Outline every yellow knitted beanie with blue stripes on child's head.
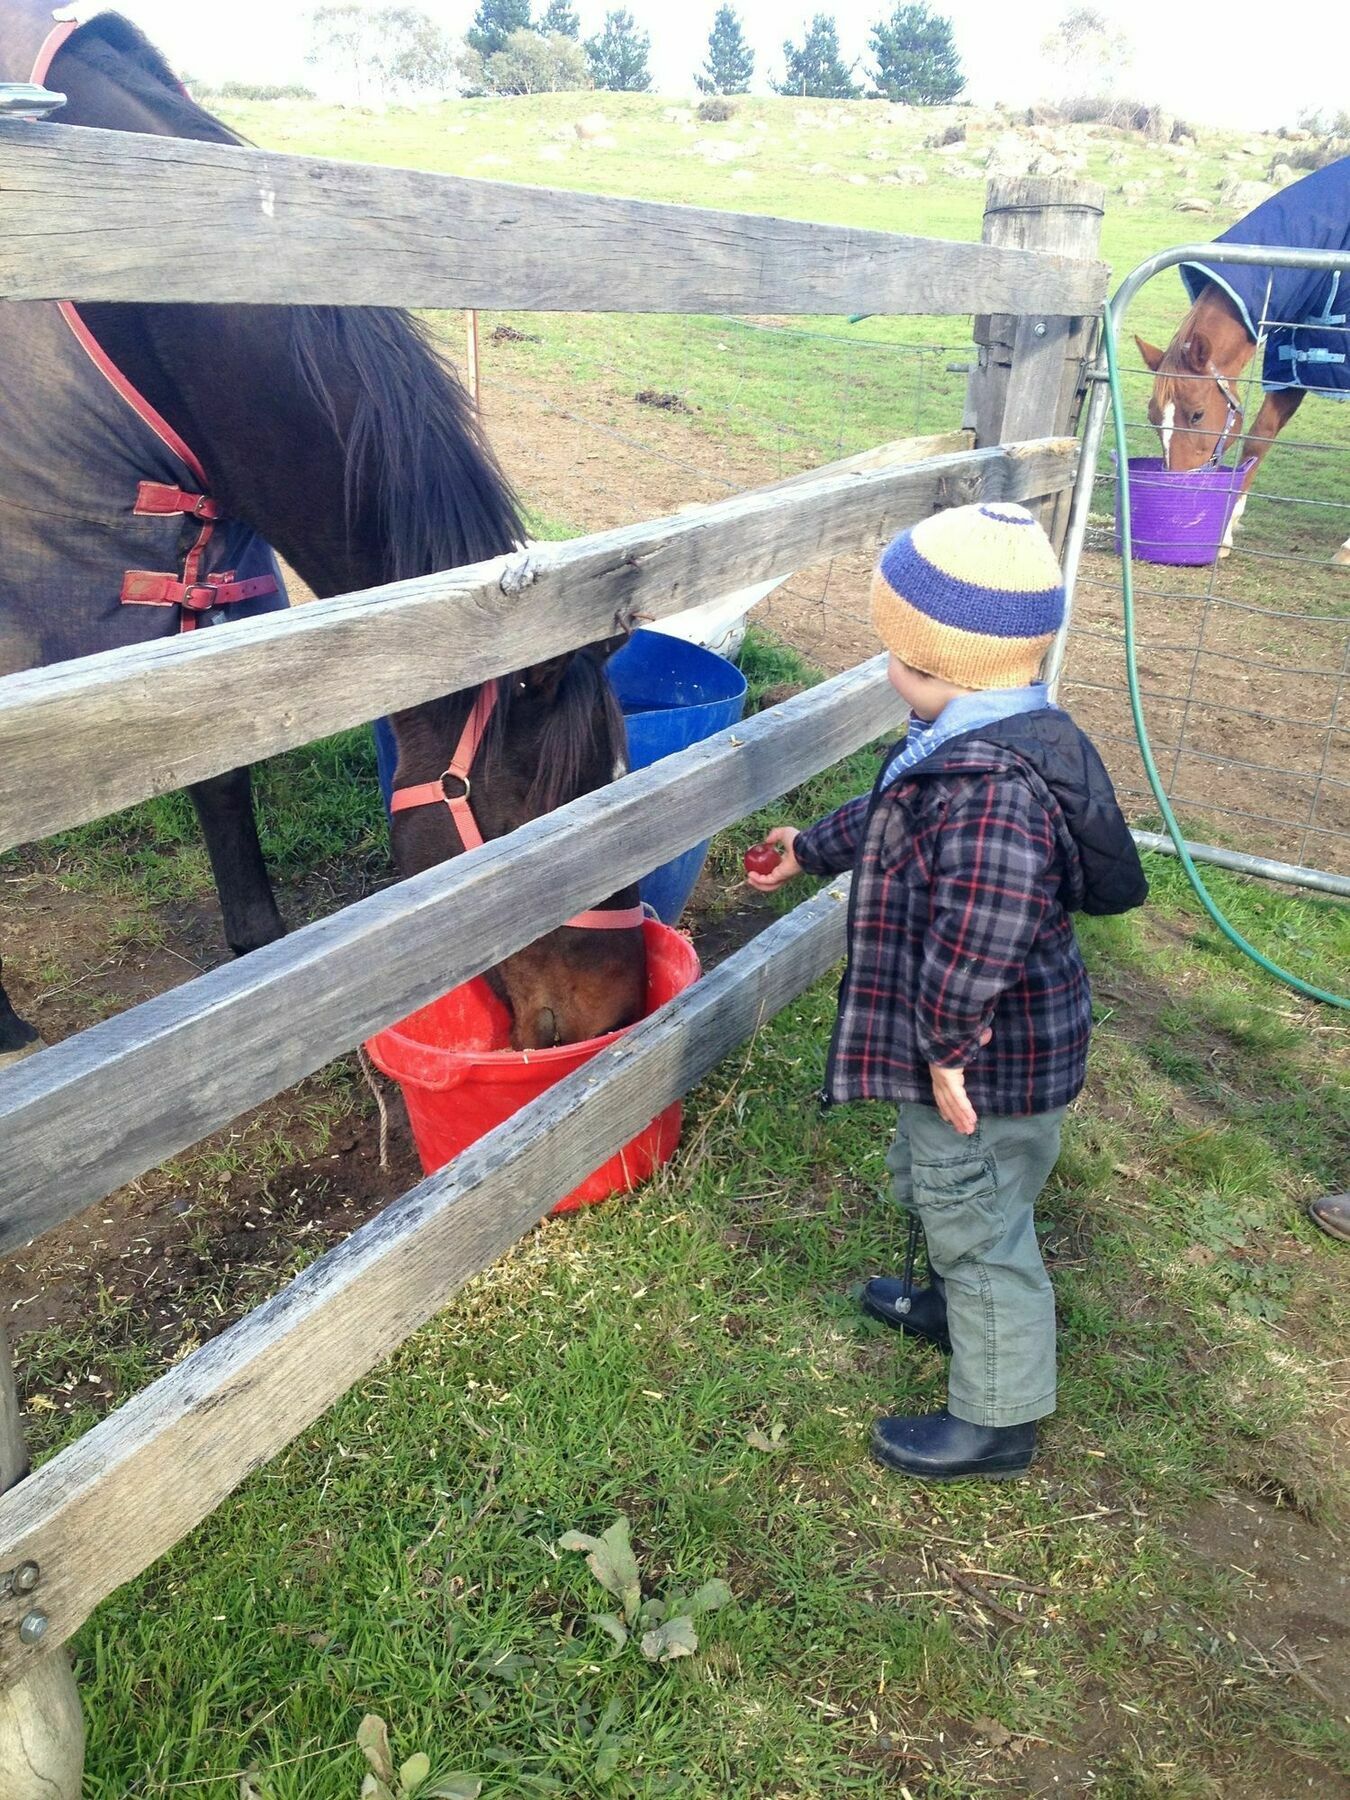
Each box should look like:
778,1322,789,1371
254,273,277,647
871,500,1064,688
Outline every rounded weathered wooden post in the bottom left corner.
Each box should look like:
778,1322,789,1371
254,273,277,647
0,1327,85,1800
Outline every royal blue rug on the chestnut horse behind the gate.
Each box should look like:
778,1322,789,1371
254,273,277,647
1181,157,1350,400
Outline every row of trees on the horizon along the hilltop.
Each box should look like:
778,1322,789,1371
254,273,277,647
308,0,965,106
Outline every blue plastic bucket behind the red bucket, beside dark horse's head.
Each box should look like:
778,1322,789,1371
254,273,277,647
605,632,745,925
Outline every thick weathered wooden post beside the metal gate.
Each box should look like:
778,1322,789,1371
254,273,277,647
965,175,1105,547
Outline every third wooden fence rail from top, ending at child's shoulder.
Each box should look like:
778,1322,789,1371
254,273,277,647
0,655,900,1255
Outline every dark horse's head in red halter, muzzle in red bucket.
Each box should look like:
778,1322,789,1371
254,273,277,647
392,639,646,1049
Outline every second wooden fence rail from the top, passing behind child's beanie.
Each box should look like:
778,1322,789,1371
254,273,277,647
0,439,1078,850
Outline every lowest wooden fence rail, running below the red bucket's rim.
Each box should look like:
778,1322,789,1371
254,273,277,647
0,884,846,1683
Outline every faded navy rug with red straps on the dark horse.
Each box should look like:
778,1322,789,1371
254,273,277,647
0,0,286,675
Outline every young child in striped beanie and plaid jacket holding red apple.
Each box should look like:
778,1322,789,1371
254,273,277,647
751,502,1148,1480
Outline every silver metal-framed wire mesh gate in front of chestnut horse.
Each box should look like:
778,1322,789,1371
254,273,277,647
1048,241,1350,896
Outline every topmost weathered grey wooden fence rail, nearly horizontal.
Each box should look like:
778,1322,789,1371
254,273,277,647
0,122,1107,315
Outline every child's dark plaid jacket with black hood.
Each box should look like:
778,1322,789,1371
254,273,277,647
796,707,1148,1114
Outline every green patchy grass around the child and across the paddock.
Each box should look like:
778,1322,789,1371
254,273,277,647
0,95,1350,1800
